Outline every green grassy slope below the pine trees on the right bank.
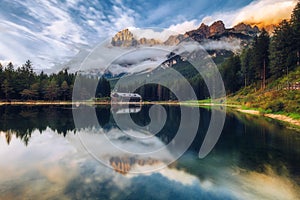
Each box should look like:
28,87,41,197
227,67,300,119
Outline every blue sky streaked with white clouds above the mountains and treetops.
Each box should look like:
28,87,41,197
0,0,296,69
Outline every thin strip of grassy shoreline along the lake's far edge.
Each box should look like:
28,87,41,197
0,100,300,127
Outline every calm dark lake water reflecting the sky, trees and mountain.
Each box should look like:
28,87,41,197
0,106,300,200
